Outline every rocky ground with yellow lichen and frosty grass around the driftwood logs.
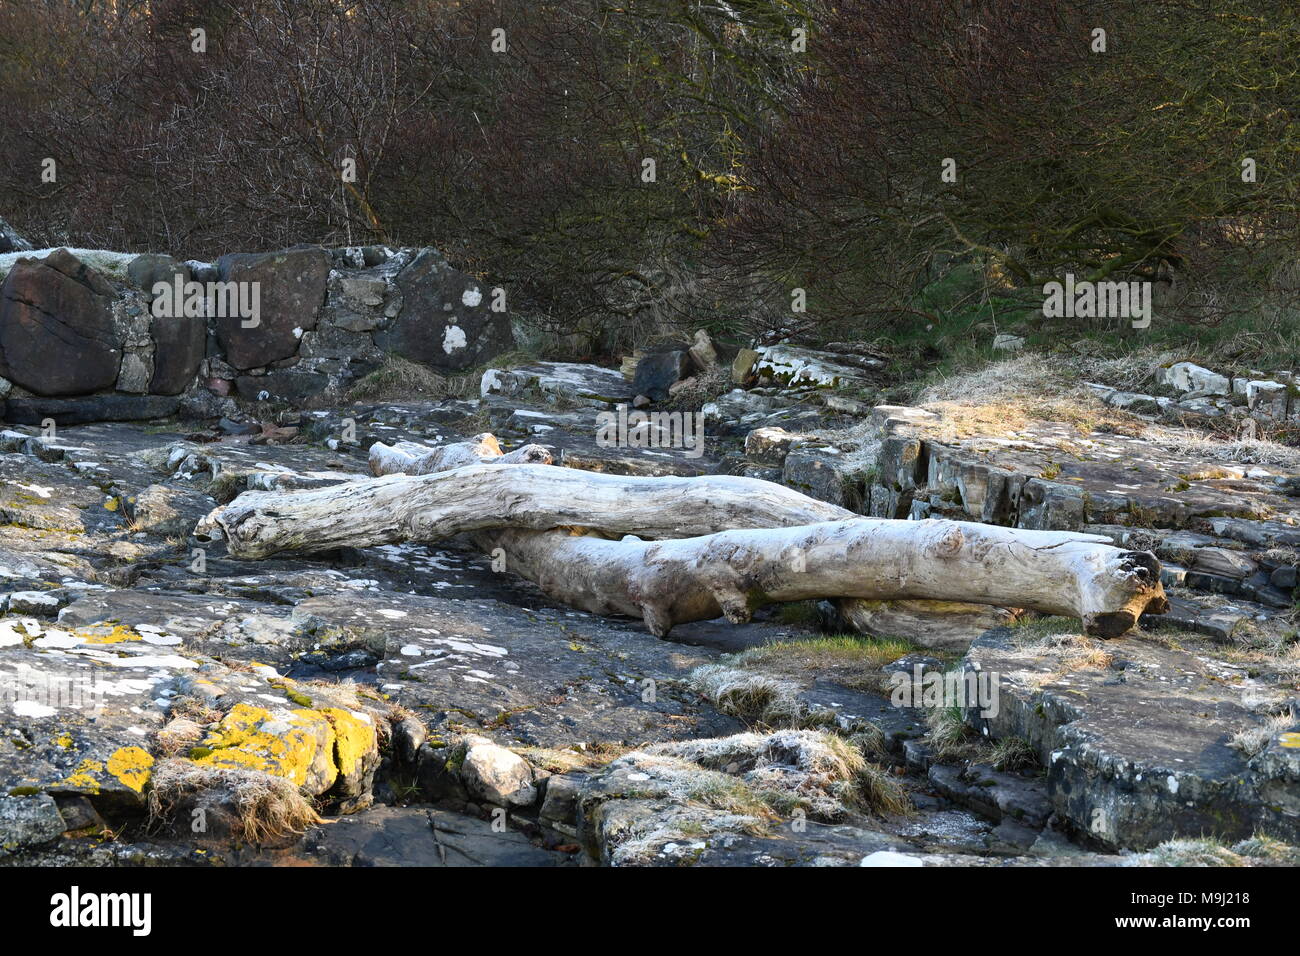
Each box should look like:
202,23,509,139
0,343,1300,866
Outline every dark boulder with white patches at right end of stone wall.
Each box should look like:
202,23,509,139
374,248,515,372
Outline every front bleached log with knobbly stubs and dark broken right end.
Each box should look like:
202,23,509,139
475,518,1169,637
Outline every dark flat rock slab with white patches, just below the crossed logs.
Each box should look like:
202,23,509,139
280,592,738,748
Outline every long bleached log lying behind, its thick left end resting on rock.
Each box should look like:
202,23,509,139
195,464,852,558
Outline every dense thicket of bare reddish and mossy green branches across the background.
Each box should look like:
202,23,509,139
0,0,1300,350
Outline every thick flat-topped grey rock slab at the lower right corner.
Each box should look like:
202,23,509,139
966,628,1300,849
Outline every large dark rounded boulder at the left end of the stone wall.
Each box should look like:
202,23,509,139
0,248,122,395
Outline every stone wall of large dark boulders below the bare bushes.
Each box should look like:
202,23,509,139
0,246,514,424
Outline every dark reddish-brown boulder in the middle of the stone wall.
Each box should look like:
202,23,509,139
215,248,330,369
